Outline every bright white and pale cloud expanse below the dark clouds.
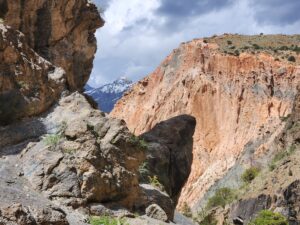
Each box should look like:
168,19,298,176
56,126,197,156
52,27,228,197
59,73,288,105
89,0,300,86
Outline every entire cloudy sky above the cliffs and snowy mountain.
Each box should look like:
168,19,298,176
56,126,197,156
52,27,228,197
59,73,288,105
89,0,300,87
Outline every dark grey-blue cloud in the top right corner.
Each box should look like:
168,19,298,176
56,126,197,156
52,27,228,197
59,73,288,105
250,0,300,25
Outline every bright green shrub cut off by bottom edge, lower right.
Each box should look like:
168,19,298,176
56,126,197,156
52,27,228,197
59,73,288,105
249,210,289,225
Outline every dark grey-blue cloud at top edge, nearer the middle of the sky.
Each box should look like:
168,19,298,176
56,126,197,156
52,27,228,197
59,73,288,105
157,0,233,19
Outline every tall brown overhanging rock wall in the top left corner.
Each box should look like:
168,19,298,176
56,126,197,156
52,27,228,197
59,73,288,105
0,0,104,91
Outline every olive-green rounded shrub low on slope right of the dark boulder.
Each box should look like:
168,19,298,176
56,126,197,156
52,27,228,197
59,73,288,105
206,187,236,210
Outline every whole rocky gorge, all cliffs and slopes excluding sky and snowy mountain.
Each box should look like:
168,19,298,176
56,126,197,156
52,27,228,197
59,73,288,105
0,0,300,225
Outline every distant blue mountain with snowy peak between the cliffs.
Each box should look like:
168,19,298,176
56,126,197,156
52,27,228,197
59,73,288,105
85,77,133,113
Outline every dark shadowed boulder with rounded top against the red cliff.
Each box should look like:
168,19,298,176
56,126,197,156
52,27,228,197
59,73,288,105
141,115,196,205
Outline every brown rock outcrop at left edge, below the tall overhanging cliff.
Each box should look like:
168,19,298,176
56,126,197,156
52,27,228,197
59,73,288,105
0,24,65,125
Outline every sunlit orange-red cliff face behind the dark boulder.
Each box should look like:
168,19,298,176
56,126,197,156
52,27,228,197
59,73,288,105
111,37,300,206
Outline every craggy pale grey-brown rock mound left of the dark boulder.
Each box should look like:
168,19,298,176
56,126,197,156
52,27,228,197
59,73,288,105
21,93,144,208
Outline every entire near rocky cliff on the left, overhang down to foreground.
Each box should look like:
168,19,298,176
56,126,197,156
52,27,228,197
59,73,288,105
0,0,195,225
